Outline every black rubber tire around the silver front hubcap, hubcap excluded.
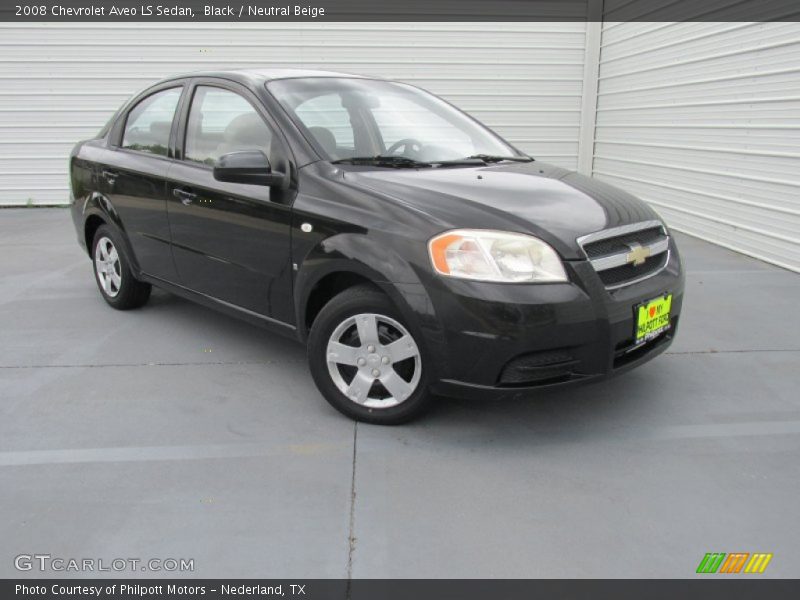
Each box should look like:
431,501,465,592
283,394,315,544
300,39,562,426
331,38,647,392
308,287,430,425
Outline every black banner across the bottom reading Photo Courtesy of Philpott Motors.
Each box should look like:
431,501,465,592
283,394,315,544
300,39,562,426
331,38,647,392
0,576,800,600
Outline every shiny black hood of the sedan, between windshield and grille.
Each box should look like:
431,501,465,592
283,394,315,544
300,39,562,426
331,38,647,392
344,161,659,258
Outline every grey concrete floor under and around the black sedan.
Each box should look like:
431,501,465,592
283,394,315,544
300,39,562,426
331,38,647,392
0,209,800,578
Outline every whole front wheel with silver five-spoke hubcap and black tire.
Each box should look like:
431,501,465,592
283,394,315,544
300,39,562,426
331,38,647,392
308,286,431,425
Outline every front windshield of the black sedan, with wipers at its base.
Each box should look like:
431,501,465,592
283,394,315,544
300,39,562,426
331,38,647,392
267,77,530,167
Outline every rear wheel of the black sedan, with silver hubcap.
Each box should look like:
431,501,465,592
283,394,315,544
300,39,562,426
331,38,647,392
92,225,152,310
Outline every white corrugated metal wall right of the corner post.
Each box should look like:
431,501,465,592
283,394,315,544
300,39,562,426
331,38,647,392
593,23,800,271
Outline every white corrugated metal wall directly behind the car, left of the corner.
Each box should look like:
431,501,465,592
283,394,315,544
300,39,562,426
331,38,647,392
0,23,585,205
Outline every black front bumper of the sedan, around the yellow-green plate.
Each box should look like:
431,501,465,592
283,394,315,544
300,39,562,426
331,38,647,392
426,238,684,398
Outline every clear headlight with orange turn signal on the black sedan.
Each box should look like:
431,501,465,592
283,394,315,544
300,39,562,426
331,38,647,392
428,229,567,283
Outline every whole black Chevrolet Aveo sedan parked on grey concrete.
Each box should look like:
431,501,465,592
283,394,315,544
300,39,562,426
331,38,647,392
71,70,684,424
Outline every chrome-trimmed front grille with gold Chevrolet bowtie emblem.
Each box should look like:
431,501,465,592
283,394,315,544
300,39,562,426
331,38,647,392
578,221,669,289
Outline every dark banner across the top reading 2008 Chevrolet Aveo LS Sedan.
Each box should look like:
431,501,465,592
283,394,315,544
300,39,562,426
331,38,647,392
0,0,800,23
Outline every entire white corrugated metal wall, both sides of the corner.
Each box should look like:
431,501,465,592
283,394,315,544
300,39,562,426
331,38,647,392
0,19,800,271
